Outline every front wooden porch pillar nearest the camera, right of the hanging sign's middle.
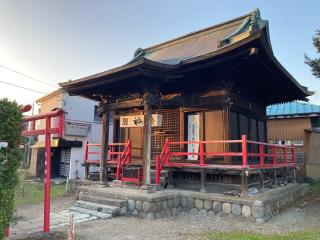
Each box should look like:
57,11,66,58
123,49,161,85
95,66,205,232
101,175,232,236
142,92,152,185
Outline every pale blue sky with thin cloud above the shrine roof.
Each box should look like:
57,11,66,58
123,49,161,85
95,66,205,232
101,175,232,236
0,0,320,104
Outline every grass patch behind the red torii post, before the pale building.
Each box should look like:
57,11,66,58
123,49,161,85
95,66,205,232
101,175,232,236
15,181,65,206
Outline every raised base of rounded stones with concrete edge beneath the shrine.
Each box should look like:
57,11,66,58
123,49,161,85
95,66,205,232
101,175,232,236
75,184,308,223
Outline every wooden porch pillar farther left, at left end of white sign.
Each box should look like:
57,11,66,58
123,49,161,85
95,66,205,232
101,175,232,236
100,102,110,185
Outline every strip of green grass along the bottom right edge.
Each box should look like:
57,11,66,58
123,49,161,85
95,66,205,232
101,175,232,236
201,229,320,240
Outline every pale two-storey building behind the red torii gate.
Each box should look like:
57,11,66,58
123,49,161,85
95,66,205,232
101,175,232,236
30,89,107,179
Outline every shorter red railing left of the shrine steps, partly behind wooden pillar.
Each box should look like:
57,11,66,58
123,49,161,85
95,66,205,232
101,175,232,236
84,139,131,180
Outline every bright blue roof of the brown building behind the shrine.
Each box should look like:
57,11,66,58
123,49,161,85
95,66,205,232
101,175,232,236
267,102,320,116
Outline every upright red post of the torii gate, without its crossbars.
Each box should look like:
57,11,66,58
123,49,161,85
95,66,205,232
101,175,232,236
43,117,51,232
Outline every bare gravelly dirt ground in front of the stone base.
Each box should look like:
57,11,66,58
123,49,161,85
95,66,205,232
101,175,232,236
11,188,320,240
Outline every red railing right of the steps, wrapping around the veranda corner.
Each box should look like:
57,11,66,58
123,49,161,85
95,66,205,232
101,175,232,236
155,135,295,184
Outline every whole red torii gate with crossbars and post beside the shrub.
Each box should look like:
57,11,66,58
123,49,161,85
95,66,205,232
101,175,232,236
22,109,64,232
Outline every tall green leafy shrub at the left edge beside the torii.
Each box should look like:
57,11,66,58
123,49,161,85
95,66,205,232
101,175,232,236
0,99,22,239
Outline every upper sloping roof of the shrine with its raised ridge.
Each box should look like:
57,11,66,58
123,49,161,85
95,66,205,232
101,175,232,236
131,9,267,65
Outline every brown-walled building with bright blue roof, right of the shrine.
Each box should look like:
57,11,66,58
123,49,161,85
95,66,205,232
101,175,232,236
267,102,320,179
